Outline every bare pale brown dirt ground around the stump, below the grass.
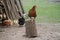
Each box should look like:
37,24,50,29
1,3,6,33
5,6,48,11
0,23,60,40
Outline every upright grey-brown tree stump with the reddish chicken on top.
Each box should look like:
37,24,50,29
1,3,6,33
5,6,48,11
25,19,37,37
